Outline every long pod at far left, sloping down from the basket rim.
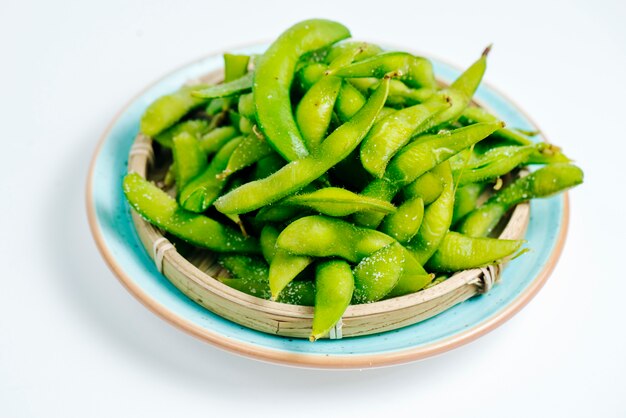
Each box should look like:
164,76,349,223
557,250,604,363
123,173,259,253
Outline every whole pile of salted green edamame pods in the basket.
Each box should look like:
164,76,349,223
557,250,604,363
123,19,583,341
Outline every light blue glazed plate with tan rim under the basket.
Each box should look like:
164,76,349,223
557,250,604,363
86,45,568,368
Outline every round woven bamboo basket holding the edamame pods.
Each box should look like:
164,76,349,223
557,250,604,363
128,71,530,339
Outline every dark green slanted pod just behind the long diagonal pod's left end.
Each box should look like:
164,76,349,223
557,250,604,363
178,137,243,213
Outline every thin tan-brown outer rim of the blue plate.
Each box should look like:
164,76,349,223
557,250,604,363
85,44,569,369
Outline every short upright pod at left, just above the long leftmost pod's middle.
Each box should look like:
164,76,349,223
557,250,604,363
172,132,207,193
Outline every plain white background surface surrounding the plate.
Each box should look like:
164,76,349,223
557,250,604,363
0,0,626,418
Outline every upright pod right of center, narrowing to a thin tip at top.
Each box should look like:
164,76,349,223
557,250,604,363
407,162,454,265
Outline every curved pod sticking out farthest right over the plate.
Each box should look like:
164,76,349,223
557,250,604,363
459,163,583,237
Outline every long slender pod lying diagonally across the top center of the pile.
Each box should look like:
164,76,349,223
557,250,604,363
215,80,389,213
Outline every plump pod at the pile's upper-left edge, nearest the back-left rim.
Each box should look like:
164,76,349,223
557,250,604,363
139,86,207,137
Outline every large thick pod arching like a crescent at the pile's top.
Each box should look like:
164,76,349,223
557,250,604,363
253,19,350,161
